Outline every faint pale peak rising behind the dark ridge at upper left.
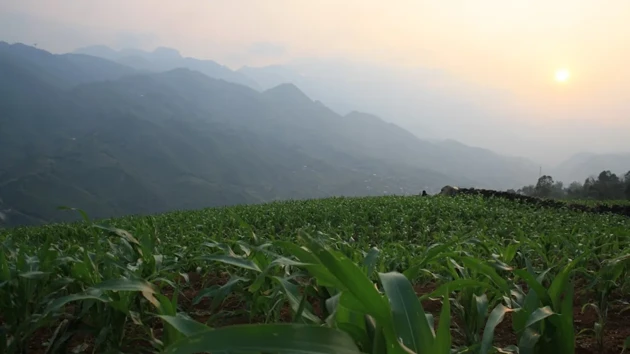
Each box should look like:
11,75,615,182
75,46,260,89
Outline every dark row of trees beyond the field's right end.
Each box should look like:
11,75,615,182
509,171,630,200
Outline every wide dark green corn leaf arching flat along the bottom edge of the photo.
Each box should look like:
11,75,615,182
164,324,361,354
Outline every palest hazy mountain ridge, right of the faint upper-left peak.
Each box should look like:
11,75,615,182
238,59,528,142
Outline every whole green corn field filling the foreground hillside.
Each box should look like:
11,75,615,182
0,195,630,354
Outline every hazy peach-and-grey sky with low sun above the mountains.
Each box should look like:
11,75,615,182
0,0,630,162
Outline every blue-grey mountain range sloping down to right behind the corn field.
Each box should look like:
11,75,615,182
0,42,628,225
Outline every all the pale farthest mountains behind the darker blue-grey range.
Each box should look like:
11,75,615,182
69,46,630,186
